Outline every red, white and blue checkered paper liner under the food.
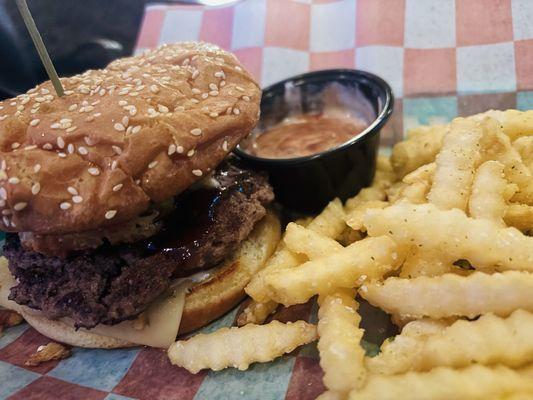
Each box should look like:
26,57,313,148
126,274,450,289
0,0,533,400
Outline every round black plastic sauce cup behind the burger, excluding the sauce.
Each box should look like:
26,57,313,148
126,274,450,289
235,69,394,214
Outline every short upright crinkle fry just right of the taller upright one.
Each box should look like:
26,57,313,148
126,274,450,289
468,161,516,227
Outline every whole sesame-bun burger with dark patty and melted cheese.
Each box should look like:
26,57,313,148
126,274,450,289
0,43,280,348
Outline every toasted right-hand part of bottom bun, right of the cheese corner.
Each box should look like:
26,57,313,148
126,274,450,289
179,211,281,334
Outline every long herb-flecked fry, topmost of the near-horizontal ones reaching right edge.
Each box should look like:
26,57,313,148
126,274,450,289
364,203,533,271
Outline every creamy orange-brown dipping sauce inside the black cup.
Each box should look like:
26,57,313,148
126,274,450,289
246,114,368,158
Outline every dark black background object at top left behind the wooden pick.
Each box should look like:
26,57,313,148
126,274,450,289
0,0,146,99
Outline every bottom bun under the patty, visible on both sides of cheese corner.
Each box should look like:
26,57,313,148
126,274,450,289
0,211,281,349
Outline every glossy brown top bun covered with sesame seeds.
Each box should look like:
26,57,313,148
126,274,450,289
0,43,261,234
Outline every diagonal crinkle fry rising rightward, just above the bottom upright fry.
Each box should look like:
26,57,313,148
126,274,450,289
265,236,403,306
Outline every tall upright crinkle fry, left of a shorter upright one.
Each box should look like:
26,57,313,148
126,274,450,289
428,118,483,210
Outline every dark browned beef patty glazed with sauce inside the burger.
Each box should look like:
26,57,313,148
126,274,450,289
4,163,274,328
